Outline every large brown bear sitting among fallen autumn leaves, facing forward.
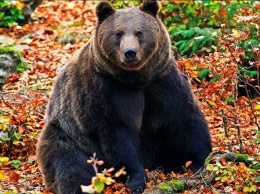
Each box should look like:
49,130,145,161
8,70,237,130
37,0,211,194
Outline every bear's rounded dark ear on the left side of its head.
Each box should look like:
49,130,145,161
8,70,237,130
96,1,116,24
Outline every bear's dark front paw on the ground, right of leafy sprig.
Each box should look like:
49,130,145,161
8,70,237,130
126,174,148,194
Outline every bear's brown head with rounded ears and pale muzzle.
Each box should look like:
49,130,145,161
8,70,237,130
95,0,170,72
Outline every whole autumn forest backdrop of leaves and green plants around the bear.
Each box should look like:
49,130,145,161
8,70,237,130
0,0,260,194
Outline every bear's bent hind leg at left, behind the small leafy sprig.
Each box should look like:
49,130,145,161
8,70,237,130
37,125,95,194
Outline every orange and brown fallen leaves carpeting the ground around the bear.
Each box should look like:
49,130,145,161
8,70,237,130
0,1,260,194
